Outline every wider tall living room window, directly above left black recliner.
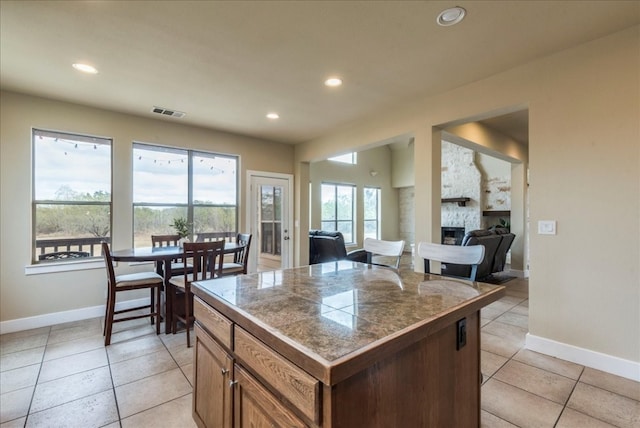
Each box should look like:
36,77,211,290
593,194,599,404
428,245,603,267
321,183,355,243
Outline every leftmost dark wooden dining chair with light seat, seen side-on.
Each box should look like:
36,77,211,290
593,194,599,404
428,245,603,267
102,242,164,346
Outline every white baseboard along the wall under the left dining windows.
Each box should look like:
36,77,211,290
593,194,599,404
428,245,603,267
0,297,149,334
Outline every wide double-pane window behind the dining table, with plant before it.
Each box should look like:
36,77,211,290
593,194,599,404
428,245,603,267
133,143,238,247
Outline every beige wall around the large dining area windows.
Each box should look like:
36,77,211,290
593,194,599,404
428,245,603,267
0,92,294,321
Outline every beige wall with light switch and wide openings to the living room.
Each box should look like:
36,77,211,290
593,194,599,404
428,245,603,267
296,26,640,368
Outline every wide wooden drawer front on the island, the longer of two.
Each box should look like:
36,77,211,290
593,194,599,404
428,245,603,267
234,327,320,423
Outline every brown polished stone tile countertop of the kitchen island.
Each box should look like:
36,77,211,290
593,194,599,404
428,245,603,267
192,261,505,385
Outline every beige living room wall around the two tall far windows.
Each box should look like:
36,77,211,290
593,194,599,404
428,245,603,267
310,145,400,249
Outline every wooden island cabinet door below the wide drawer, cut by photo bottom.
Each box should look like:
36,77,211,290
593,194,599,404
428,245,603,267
234,365,307,428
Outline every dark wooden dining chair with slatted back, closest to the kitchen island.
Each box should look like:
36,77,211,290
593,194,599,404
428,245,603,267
169,241,224,347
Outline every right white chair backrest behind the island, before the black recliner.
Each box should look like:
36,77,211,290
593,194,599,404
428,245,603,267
418,242,485,281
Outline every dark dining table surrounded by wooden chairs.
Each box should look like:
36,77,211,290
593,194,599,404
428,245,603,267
111,241,245,334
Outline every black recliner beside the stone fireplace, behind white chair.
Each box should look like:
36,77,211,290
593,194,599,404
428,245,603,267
441,227,515,282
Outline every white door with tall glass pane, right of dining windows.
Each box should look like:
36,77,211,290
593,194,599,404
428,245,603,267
247,171,293,272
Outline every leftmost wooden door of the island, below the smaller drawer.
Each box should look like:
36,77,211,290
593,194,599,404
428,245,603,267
193,323,233,428
